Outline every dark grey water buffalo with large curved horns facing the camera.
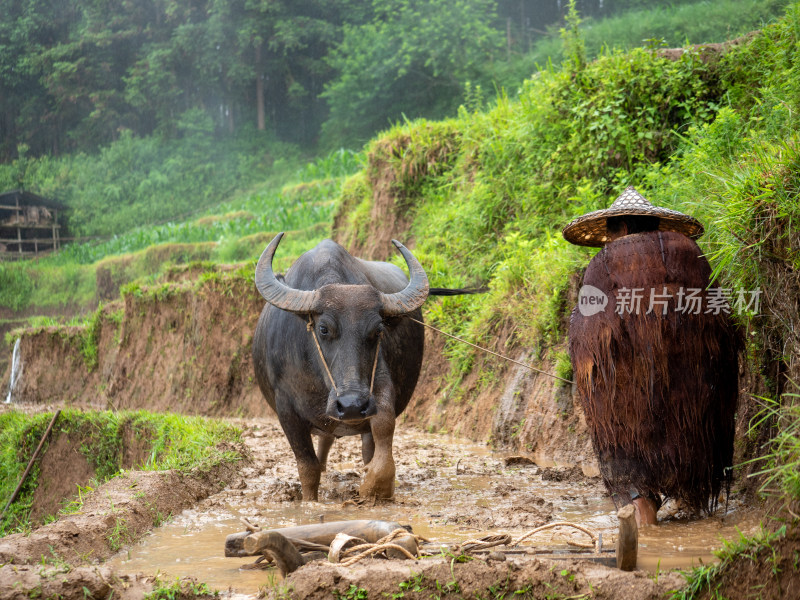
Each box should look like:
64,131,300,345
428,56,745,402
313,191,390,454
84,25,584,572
253,233,429,500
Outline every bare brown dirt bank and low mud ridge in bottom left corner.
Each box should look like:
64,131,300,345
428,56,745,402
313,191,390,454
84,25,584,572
0,405,244,600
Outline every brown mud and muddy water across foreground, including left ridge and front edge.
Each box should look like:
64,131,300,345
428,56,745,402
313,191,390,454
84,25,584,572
0,404,757,599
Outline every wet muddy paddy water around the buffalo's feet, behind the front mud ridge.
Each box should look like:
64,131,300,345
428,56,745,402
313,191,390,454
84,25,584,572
109,421,757,598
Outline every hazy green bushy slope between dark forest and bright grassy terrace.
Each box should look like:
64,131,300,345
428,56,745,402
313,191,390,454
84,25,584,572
0,131,300,236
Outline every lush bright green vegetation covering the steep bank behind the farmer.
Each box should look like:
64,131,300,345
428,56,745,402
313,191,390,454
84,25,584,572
326,3,800,593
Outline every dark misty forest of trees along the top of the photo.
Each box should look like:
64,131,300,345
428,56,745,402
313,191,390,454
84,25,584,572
0,0,775,161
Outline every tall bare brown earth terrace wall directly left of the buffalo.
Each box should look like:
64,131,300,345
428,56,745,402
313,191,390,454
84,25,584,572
2,271,268,416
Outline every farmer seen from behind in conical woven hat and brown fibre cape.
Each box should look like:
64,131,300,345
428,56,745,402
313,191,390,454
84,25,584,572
563,187,741,525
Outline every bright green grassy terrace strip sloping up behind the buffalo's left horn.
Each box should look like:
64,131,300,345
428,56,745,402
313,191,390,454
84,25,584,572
0,150,363,313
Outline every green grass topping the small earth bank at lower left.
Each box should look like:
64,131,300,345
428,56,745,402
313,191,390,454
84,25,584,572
0,409,241,535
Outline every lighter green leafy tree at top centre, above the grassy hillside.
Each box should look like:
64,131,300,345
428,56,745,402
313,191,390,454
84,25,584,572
322,0,503,146
